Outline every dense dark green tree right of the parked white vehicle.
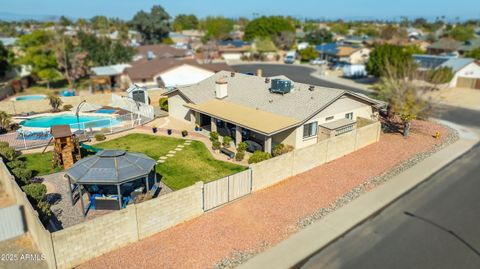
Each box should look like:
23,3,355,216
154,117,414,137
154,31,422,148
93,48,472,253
366,44,412,77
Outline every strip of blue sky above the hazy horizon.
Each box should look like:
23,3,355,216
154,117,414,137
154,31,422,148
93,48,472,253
0,0,480,19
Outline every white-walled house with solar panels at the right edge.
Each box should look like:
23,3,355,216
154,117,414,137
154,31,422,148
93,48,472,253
413,55,480,89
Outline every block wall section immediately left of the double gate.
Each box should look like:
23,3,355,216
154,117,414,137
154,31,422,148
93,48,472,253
136,182,203,239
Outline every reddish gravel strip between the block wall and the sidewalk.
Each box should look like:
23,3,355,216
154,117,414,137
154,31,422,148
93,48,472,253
79,122,448,268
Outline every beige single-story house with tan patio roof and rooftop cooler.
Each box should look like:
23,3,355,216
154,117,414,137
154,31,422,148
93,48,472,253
165,71,381,152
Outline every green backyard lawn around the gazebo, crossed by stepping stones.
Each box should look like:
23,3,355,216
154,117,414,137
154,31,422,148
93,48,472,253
24,134,246,190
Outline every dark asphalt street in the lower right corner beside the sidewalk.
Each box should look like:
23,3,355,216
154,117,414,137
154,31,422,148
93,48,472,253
296,144,480,269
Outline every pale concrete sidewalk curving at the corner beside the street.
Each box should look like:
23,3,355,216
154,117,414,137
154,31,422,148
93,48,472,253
242,121,479,269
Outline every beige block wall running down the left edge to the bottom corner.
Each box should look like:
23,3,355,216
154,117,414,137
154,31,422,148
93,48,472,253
0,160,56,268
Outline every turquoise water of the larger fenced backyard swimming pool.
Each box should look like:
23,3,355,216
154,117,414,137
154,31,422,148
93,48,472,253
20,115,120,129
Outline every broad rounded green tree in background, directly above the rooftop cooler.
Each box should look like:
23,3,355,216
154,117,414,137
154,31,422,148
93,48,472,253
244,16,295,40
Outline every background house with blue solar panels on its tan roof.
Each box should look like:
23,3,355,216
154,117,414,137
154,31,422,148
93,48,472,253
315,43,370,64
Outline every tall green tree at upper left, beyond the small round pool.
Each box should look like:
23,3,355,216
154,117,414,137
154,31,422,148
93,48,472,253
18,30,59,88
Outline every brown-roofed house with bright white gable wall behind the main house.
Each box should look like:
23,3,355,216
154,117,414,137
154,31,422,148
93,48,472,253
125,58,232,88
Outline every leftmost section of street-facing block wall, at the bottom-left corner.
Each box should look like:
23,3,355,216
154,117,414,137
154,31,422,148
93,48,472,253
52,205,138,268
